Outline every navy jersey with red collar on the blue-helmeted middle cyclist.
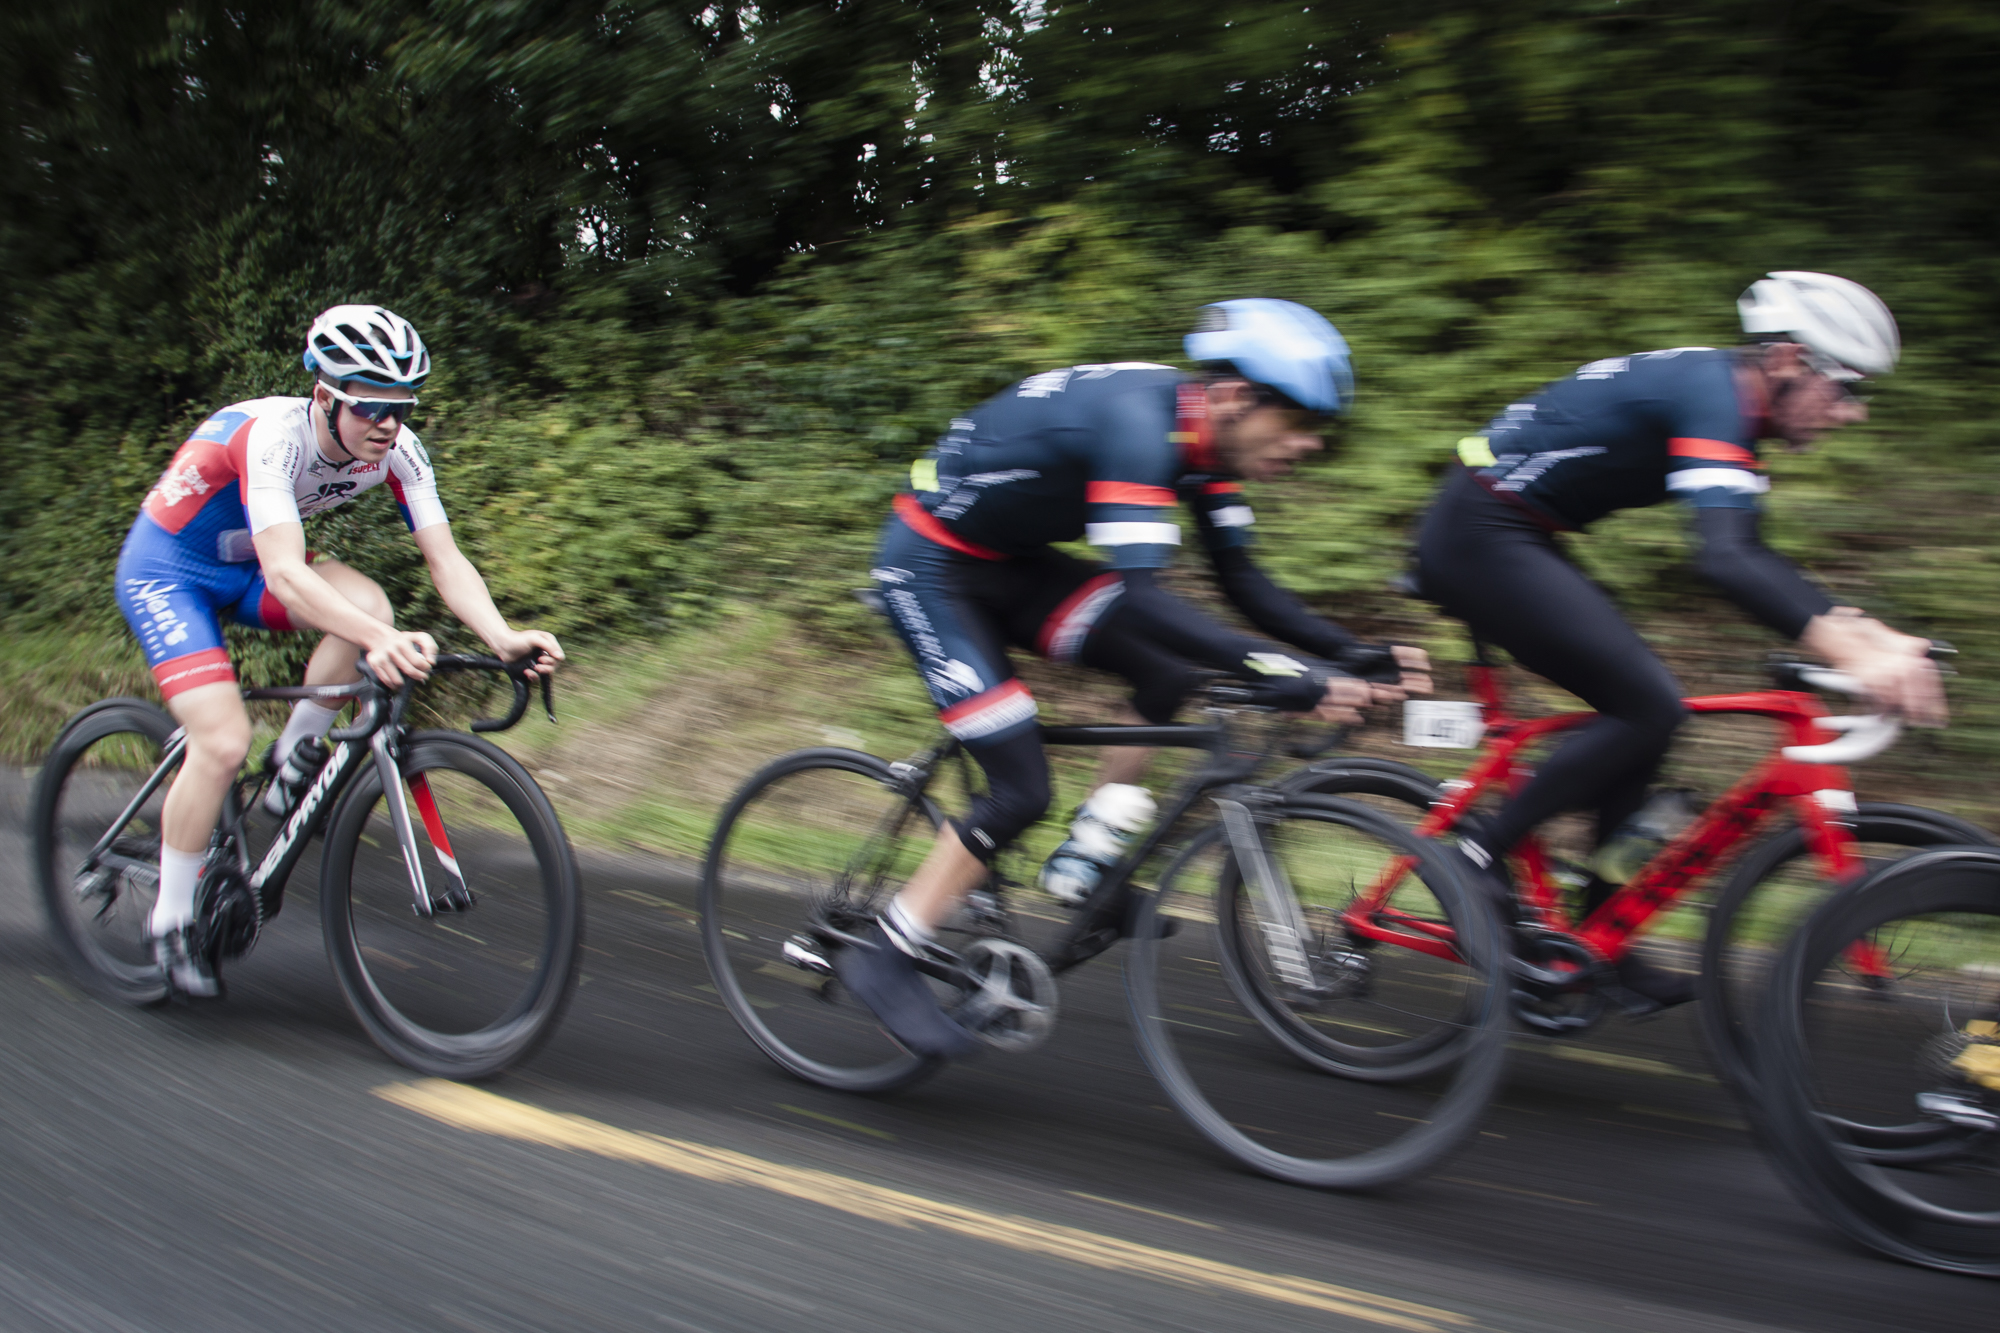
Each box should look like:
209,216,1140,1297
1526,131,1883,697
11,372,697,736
896,362,1252,570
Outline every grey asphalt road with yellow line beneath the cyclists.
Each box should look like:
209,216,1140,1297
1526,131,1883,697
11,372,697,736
0,771,1996,1333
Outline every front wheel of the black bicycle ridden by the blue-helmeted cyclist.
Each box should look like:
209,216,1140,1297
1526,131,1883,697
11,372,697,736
1126,797,1508,1189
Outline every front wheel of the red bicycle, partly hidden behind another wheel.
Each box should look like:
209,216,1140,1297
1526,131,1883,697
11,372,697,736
1696,801,1994,1099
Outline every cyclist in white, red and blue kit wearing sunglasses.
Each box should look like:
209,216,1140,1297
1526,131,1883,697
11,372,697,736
116,306,562,984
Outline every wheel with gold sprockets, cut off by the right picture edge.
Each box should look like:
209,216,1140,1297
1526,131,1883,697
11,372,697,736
1756,847,2000,1277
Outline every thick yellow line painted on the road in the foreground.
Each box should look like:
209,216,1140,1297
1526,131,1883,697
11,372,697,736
376,1079,1472,1333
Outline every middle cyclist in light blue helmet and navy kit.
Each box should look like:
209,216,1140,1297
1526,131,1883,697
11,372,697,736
836,300,1428,1055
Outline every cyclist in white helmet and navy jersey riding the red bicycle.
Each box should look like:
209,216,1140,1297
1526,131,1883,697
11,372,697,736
1418,272,1944,1009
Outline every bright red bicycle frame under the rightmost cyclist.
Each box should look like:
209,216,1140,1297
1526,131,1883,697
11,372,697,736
1344,662,1862,961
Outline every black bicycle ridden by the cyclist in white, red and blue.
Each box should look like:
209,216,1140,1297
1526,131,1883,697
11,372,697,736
34,654,582,1079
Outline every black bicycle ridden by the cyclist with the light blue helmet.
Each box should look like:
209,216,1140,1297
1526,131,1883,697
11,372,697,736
702,685,1510,1189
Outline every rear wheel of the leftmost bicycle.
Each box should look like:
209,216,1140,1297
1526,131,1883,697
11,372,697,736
32,699,174,1007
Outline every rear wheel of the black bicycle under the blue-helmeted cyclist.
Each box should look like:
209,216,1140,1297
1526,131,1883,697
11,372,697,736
700,749,944,1093
